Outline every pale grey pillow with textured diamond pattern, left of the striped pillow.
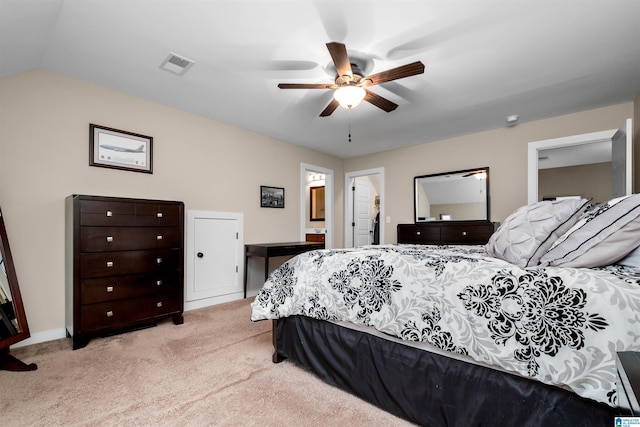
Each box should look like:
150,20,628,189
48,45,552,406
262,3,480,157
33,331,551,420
485,199,588,267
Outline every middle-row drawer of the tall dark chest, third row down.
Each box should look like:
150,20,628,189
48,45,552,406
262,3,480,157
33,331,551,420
80,249,182,279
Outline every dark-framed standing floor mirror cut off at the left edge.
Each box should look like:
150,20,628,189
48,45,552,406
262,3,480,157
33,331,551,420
0,210,37,371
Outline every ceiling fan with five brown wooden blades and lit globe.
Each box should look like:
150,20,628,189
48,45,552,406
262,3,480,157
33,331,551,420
278,42,424,117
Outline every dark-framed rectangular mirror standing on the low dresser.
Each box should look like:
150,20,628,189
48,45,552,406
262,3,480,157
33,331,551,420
413,167,490,222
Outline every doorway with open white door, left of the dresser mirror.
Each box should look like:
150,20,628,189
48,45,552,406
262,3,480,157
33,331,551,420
344,168,386,248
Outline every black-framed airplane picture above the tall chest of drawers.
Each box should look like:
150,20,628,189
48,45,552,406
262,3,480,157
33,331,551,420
89,124,153,173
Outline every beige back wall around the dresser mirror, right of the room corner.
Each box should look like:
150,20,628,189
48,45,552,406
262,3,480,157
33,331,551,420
344,103,639,243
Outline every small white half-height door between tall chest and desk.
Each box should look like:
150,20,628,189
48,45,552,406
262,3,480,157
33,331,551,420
186,217,242,301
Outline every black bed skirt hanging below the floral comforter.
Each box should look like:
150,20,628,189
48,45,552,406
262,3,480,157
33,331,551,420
274,316,616,427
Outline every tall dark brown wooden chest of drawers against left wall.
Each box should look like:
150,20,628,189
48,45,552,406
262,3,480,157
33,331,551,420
65,195,184,350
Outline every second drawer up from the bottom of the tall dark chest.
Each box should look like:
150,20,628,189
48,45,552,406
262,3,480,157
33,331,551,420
80,270,182,304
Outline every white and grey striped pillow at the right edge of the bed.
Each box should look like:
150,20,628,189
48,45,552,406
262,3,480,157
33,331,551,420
540,194,640,267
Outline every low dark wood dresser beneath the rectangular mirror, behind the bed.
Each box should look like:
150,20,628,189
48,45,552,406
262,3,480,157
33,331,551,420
398,220,495,245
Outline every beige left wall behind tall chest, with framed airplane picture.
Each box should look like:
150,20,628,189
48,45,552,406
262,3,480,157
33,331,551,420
0,70,344,334
